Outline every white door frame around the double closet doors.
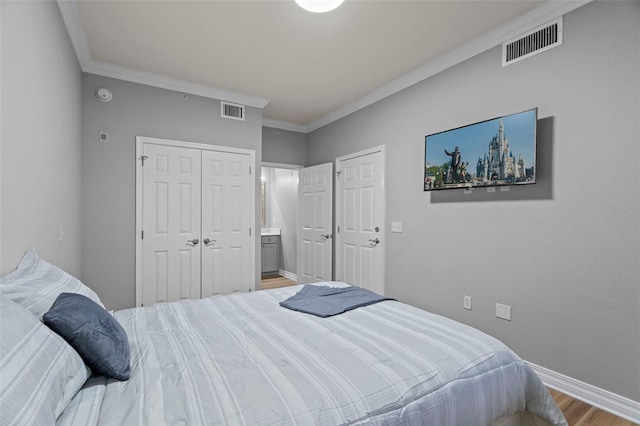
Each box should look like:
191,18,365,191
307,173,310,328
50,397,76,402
134,136,255,306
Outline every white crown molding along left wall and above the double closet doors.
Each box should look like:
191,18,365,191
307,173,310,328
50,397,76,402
52,0,269,109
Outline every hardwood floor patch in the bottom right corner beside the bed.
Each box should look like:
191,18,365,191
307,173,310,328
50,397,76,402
549,388,637,426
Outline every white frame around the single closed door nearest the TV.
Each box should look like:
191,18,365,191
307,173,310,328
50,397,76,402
333,145,388,294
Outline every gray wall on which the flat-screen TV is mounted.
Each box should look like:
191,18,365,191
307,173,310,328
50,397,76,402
308,1,640,401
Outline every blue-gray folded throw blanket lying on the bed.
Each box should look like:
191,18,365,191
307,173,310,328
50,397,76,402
280,284,395,318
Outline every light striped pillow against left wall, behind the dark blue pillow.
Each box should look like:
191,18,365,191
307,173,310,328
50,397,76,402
0,249,104,318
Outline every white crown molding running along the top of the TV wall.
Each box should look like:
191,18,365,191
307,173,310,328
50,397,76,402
307,0,592,132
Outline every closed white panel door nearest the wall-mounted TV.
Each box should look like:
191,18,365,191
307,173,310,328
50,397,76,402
336,147,385,294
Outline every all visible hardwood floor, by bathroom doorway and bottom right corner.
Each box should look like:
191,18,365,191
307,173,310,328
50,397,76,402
260,275,639,426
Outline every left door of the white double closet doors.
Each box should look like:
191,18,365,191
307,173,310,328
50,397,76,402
142,144,201,305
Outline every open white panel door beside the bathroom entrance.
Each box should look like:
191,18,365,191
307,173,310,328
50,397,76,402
297,163,333,284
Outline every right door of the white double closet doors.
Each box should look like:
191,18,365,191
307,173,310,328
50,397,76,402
202,151,255,297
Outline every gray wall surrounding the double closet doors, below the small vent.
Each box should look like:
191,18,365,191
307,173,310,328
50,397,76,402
82,74,262,310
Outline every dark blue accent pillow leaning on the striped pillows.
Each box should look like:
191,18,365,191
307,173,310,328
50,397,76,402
42,293,131,380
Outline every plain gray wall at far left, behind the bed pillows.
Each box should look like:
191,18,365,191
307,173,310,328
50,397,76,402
0,1,82,277
